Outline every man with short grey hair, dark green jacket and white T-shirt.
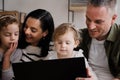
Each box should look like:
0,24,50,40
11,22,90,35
78,0,120,80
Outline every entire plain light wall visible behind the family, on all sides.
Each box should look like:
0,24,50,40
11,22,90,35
0,0,120,28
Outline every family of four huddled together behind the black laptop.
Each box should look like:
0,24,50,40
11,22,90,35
0,0,120,80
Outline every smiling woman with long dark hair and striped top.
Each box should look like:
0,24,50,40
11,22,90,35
18,9,54,62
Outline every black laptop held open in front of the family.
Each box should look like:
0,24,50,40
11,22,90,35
12,57,87,80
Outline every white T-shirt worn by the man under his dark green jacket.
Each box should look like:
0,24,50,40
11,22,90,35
88,39,113,80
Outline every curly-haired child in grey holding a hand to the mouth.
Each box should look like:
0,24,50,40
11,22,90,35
0,15,22,80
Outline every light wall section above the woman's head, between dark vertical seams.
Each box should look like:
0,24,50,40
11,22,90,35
2,0,68,26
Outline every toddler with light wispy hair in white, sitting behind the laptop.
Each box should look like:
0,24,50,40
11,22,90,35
46,23,97,80
